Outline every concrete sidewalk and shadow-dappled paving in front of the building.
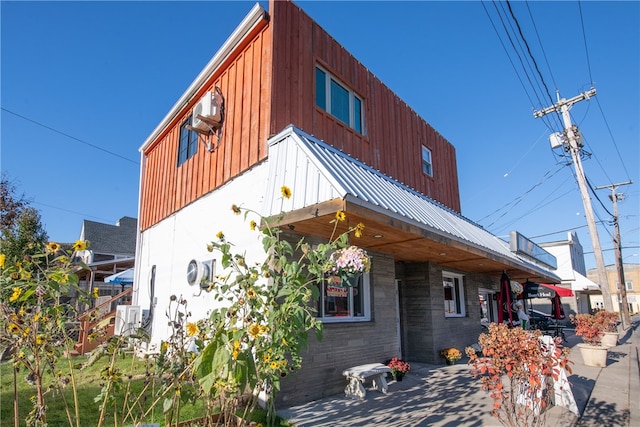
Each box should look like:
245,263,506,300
278,317,640,427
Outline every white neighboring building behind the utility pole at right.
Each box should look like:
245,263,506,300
540,231,602,313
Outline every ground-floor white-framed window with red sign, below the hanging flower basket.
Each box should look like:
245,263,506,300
316,273,371,322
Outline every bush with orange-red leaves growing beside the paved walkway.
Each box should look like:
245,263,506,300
465,323,572,426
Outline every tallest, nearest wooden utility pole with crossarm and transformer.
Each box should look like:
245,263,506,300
533,88,613,311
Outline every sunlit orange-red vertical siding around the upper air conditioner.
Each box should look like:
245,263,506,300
139,16,272,230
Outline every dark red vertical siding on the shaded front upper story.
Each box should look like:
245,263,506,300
270,1,460,211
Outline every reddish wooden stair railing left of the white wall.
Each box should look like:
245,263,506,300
73,287,133,355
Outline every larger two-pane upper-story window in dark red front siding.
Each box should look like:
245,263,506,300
316,67,364,134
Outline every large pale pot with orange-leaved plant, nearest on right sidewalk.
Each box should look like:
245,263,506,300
569,313,608,368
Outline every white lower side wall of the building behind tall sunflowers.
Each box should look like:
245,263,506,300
133,162,268,350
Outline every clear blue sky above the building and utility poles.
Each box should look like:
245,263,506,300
0,1,640,267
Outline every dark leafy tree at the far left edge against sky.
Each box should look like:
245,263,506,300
0,176,49,268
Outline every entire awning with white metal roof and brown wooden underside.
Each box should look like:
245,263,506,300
262,126,561,283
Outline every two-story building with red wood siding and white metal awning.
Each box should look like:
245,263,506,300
134,1,560,405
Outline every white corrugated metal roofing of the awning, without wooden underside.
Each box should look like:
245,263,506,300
262,125,559,280
